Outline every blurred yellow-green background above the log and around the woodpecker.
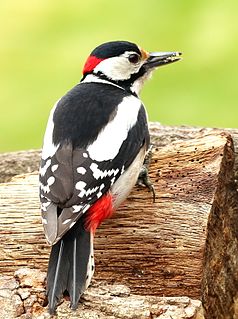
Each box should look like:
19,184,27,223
0,0,238,152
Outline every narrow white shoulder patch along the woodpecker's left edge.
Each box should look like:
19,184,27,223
41,100,60,159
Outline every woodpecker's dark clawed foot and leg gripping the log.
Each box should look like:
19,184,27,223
137,145,156,203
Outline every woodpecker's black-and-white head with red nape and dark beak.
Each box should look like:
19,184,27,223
83,41,181,94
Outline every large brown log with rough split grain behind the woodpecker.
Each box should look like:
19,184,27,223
0,123,238,319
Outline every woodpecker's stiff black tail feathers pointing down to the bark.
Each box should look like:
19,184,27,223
47,218,91,314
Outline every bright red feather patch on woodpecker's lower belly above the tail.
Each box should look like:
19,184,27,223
85,193,113,234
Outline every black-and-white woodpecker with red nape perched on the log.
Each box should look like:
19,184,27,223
40,41,180,313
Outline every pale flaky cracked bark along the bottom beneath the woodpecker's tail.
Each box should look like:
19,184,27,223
0,268,204,319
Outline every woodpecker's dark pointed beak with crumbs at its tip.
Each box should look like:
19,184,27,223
144,52,182,69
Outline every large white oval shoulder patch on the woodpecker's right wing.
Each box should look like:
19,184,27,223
87,96,141,161
